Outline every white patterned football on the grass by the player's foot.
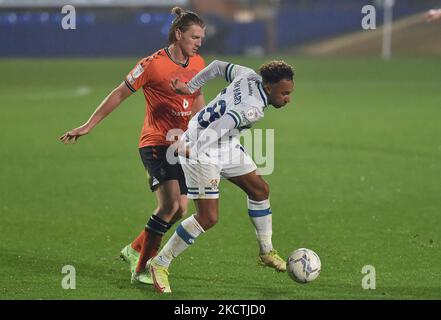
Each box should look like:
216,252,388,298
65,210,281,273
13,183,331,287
286,248,322,283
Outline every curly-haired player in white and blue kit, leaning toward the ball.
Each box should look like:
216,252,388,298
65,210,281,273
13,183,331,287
147,60,294,293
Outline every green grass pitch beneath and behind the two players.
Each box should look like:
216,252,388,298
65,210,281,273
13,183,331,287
0,57,441,300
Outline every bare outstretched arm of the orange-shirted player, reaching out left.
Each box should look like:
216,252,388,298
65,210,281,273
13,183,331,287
59,82,132,144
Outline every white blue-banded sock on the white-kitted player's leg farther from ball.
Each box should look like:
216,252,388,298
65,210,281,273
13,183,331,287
154,215,204,268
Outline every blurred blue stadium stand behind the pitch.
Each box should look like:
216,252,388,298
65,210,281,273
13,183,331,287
0,0,441,57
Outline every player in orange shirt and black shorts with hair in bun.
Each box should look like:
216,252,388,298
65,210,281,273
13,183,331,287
60,7,205,284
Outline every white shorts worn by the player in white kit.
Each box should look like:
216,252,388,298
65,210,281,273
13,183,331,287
179,139,257,199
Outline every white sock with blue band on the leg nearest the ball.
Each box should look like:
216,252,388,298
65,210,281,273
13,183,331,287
248,198,273,254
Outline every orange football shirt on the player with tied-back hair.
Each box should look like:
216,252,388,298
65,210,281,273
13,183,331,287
125,48,205,148
